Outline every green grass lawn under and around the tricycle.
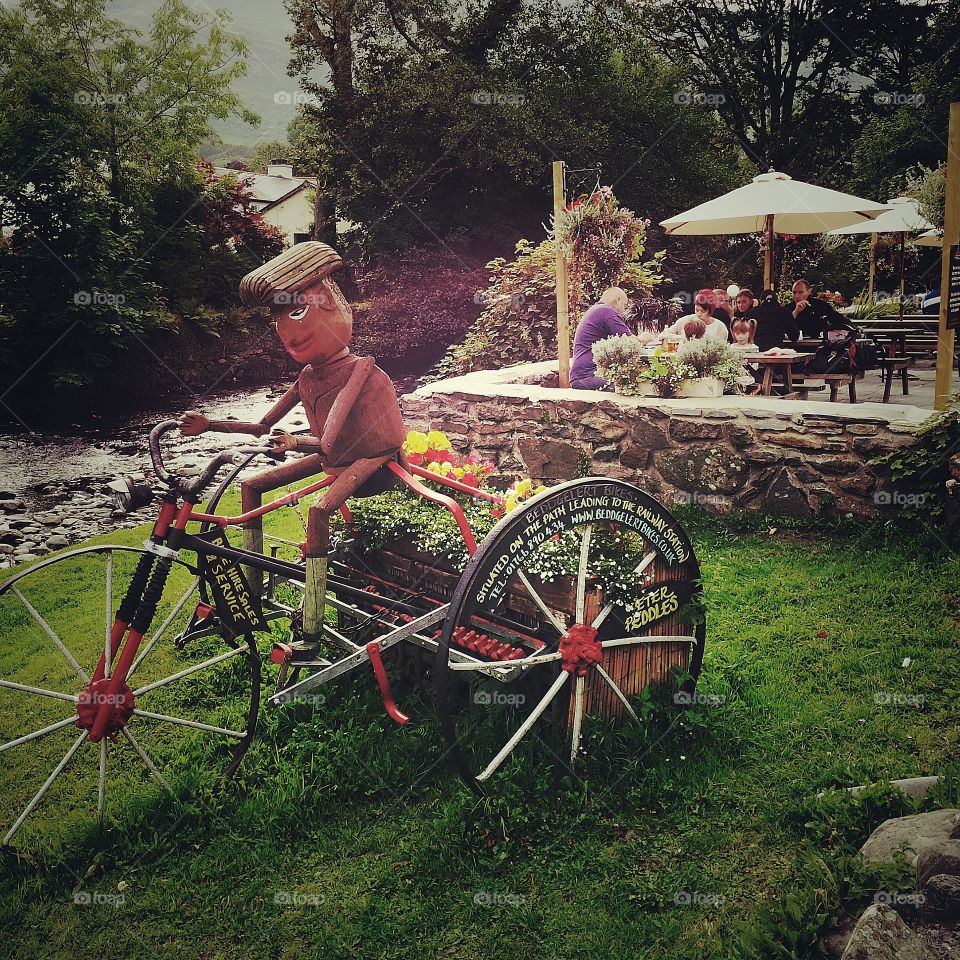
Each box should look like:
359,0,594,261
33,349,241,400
0,506,960,960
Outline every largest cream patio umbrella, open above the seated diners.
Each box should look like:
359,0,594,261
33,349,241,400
660,170,887,287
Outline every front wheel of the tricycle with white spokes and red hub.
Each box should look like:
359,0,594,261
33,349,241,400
0,546,260,850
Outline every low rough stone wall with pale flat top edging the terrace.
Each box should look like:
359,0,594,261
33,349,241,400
401,363,930,517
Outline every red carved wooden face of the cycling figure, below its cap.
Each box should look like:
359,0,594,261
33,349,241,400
270,279,353,366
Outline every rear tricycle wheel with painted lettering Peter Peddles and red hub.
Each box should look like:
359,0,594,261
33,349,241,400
436,478,706,790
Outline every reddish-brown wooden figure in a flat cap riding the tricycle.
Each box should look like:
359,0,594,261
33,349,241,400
181,241,406,658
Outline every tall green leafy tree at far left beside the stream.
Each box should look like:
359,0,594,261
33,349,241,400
0,0,276,406
